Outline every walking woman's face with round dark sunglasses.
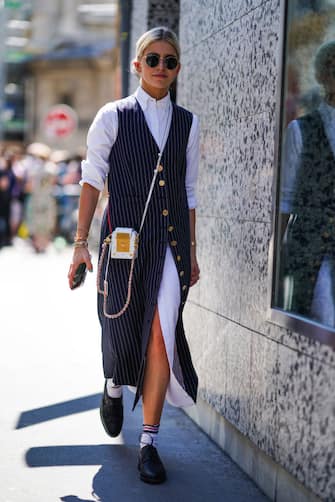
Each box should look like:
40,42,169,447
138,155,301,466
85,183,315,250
134,40,180,99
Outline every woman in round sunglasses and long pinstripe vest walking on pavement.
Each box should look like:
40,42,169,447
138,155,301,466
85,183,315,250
68,27,199,483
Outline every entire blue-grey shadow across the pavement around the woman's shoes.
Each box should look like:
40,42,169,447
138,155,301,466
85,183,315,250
17,389,268,502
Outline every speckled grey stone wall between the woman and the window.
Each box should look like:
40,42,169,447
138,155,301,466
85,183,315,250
178,0,335,501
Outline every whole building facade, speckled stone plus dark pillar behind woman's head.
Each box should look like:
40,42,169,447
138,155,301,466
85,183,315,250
130,0,335,502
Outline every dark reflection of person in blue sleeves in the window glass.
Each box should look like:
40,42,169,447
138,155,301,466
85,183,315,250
281,41,335,317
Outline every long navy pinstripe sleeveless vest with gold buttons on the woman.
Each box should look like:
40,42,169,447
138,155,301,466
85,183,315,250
98,97,198,407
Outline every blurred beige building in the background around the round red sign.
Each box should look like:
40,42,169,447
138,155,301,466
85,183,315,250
0,0,121,150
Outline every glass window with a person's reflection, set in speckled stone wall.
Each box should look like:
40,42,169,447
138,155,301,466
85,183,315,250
272,0,335,329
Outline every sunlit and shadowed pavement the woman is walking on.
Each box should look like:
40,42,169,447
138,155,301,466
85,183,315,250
0,240,268,502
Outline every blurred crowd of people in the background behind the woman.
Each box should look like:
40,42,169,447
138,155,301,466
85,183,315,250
0,143,82,253
